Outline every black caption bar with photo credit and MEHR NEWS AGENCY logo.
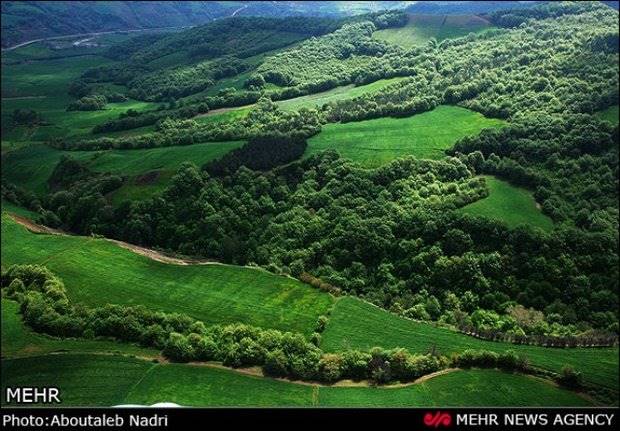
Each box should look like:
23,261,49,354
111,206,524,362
1,407,618,431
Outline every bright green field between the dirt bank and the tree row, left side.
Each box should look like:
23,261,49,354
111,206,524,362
2,214,333,335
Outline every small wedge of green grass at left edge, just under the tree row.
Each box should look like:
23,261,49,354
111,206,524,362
0,299,159,358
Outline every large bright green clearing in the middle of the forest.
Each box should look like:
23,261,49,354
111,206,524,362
305,106,504,167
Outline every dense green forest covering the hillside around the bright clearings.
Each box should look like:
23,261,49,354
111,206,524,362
4,3,618,337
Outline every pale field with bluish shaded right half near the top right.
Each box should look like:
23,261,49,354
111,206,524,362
373,14,492,48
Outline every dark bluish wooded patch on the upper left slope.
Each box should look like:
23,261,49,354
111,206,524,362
74,17,346,101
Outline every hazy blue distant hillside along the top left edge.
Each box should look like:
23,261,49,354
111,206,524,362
2,1,406,48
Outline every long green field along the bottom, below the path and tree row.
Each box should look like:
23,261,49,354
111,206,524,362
2,354,591,407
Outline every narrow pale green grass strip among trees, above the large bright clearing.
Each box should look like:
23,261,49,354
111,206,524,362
276,77,405,111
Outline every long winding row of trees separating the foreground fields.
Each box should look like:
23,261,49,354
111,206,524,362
1,265,528,383
